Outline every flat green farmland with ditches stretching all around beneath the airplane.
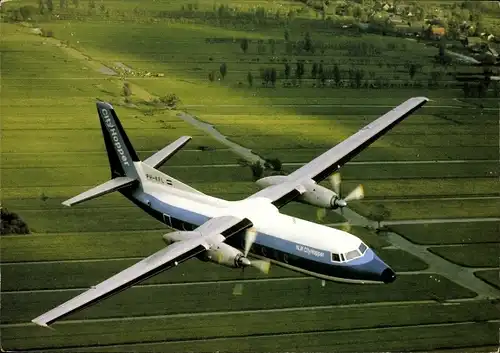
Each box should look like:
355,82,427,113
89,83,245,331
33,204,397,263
0,0,499,352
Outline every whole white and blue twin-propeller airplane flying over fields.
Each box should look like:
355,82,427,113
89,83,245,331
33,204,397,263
32,97,429,327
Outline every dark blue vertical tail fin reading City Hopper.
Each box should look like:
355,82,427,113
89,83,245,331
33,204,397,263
97,102,140,179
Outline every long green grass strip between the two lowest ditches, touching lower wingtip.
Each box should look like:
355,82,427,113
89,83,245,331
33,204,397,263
3,302,496,350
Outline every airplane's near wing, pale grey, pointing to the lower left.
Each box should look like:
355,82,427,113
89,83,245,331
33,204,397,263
32,216,252,327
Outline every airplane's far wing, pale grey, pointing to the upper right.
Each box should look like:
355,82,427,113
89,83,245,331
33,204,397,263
250,97,429,207
